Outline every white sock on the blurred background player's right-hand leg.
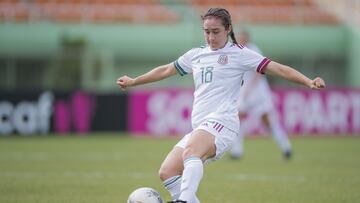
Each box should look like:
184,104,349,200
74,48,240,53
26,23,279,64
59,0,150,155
270,119,291,152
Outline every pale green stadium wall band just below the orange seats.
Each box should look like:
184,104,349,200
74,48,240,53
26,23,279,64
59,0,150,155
0,23,347,60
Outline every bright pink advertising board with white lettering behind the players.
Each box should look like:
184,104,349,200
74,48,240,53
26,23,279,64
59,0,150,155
128,88,360,136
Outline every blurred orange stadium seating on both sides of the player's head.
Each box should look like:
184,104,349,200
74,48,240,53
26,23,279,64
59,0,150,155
0,0,344,24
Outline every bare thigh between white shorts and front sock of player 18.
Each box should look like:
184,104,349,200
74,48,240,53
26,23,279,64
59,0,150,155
183,129,216,161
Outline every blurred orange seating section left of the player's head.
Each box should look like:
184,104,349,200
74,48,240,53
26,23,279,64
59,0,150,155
0,0,179,23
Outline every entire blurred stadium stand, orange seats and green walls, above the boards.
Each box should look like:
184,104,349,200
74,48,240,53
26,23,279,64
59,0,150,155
0,0,360,91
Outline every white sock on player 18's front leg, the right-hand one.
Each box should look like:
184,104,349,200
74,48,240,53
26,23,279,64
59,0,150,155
179,156,204,203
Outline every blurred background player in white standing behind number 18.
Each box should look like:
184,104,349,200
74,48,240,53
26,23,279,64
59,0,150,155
230,30,292,159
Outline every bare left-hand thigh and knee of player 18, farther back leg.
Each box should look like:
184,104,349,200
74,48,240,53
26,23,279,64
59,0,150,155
159,146,184,180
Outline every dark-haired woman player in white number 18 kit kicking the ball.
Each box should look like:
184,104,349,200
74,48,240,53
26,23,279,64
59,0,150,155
117,8,325,203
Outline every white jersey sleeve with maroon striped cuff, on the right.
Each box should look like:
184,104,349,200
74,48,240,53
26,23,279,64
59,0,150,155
241,48,271,74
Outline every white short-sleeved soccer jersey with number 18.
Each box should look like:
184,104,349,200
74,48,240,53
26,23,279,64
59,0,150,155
174,42,270,132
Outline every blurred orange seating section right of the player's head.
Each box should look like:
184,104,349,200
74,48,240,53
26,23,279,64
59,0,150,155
189,0,338,24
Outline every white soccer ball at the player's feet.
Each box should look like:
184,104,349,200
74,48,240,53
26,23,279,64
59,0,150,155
127,187,163,203
